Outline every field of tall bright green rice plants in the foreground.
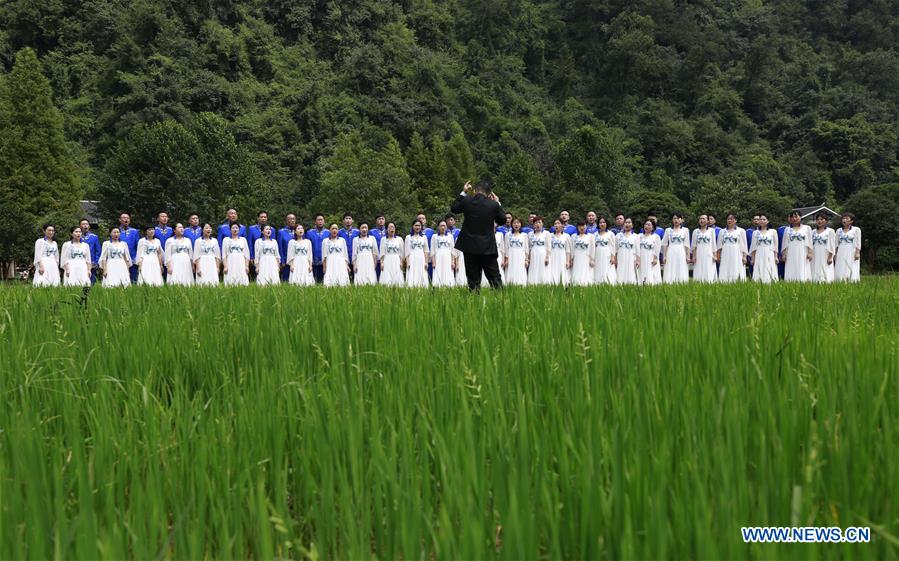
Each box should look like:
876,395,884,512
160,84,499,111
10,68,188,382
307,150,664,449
0,278,899,561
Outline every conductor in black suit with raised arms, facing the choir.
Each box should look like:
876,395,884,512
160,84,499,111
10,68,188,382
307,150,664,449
450,181,506,291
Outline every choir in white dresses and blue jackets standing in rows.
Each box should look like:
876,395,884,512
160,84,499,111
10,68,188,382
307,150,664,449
34,209,861,287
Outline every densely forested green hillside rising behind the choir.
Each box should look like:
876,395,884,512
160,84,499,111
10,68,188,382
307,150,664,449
0,0,899,266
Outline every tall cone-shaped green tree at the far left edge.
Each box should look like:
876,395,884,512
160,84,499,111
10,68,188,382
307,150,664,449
0,48,82,262
